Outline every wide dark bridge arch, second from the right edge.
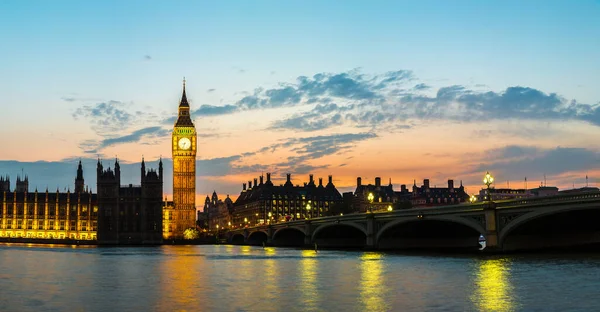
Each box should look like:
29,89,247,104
375,215,485,249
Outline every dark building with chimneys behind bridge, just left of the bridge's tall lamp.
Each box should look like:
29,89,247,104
411,179,469,207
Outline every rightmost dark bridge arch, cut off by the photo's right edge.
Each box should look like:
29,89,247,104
498,203,600,251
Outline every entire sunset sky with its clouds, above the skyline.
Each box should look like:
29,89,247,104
0,0,600,210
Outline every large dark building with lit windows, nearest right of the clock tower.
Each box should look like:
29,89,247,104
232,173,342,227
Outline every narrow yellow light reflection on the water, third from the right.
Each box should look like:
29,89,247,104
299,249,319,311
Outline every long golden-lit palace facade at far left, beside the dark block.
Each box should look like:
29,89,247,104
0,162,98,240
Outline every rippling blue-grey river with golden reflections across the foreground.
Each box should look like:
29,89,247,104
0,244,600,311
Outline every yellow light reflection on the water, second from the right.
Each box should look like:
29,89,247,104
360,252,389,311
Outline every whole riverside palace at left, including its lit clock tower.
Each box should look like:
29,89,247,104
0,81,197,245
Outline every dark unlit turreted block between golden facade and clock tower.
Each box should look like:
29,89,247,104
97,159,163,245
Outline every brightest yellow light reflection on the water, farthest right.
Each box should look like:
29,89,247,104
471,259,515,311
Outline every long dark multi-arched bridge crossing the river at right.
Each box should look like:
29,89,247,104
225,192,600,251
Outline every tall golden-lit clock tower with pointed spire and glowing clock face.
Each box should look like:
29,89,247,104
165,79,196,238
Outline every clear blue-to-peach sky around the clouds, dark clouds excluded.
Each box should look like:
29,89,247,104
0,1,600,205
